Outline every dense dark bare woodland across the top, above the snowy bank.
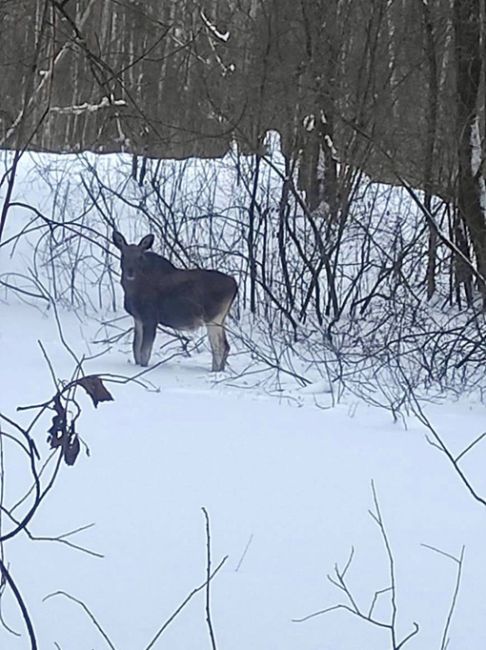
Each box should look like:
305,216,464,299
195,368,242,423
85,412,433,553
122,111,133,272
0,0,486,304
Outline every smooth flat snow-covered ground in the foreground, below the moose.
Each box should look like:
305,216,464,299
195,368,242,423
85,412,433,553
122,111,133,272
0,300,486,650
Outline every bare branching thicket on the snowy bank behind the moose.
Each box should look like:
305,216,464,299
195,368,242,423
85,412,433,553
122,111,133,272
0,144,485,412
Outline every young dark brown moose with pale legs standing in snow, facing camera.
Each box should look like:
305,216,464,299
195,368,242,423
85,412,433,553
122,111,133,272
113,230,238,371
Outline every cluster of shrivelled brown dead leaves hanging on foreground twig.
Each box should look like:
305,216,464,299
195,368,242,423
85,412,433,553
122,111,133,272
47,375,113,465
